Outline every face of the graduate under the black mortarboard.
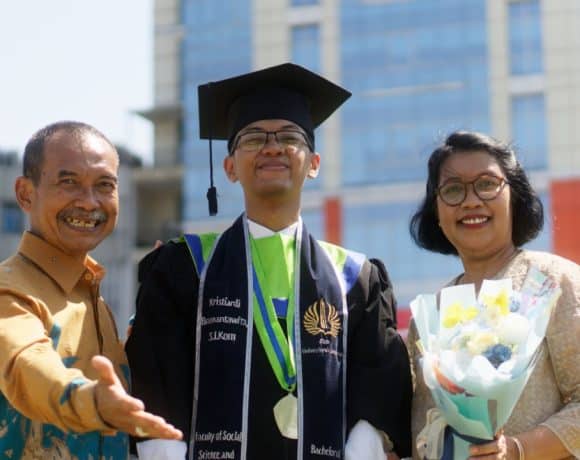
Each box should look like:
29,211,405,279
224,120,320,200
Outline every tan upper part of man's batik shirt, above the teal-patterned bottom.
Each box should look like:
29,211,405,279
0,232,128,436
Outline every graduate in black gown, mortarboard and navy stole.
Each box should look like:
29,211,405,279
126,64,412,460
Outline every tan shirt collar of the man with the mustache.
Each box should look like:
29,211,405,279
18,232,105,293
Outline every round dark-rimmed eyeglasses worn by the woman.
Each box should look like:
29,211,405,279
437,174,509,206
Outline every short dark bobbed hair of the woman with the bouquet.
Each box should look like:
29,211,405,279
409,131,544,255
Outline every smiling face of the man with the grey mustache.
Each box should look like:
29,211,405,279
16,130,119,259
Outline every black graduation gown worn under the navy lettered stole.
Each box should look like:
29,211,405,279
126,241,412,460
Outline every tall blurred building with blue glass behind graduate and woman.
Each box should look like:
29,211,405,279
144,0,580,330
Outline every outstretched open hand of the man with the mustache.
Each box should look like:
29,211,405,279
91,356,183,440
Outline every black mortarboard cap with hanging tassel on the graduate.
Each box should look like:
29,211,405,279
197,63,351,215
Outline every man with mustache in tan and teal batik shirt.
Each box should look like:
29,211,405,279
0,122,181,460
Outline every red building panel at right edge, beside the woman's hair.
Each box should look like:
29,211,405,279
550,179,580,263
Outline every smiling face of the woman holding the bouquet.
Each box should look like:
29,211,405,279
437,150,513,260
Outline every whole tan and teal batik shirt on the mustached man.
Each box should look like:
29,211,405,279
0,233,129,460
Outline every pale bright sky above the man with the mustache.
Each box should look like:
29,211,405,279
0,0,153,162
